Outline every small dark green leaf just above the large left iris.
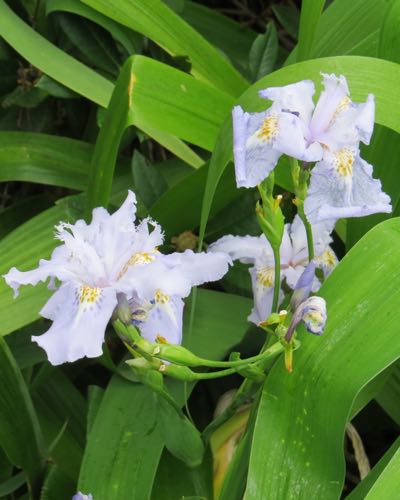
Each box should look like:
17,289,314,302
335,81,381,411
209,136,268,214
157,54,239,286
132,151,168,208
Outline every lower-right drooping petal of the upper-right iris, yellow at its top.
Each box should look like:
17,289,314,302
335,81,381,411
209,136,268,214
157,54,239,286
304,152,392,224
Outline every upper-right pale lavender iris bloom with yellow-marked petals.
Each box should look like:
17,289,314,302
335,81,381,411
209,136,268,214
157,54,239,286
233,74,391,223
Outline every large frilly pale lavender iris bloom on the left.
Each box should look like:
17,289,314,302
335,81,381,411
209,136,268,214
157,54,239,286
4,191,230,365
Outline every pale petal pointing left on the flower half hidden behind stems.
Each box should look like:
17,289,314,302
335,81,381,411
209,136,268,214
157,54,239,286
208,234,272,264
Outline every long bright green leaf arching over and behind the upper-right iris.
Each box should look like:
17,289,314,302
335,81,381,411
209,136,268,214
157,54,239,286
200,56,400,244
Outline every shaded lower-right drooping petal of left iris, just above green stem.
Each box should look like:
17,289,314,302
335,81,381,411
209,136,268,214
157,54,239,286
135,295,184,344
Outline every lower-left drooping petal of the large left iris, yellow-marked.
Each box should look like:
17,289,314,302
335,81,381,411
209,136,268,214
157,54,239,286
32,283,117,365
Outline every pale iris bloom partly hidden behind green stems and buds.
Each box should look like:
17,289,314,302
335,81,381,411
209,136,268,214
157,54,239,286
208,216,337,324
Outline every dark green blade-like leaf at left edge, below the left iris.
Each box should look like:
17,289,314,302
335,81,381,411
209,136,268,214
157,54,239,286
0,338,44,491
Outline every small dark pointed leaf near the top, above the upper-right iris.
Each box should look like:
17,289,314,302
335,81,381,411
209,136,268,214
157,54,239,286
249,21,278,82
